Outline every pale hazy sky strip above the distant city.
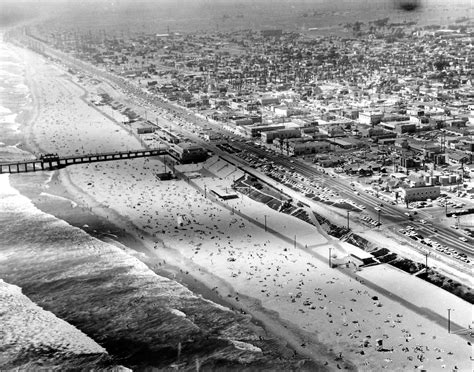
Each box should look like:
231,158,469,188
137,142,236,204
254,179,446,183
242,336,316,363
0,0,474,27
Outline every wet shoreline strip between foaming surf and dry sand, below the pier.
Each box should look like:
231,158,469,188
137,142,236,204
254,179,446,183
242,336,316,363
10,159,344,370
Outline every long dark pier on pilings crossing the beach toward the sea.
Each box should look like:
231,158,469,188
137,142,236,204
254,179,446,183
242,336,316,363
0,148,168,173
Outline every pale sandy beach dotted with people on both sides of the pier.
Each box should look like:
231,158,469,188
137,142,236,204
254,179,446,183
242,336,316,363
2,41,472,371
